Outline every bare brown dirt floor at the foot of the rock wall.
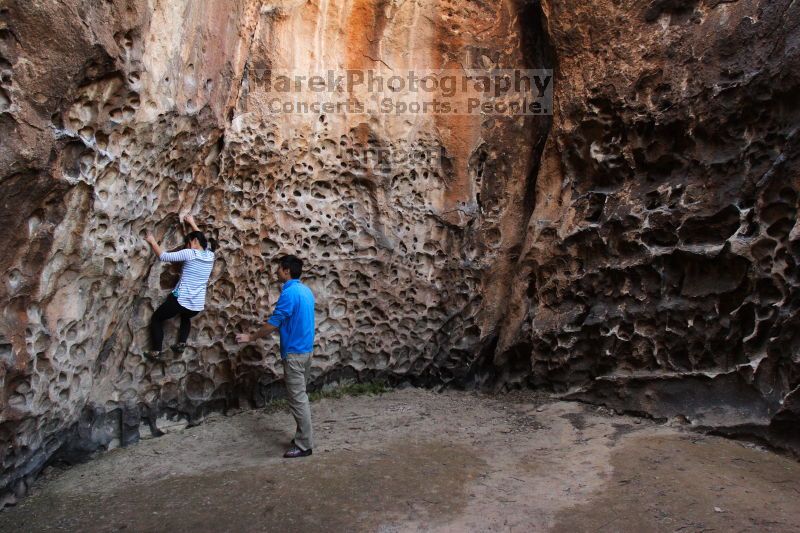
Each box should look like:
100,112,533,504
0,389,800,532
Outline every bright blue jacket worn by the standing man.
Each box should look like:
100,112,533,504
267,279,314,359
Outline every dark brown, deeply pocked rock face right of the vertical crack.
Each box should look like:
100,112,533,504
484,0,800,451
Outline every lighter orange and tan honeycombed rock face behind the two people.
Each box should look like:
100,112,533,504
0,0,550,501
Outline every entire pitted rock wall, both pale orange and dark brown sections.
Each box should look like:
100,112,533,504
0,0,800,501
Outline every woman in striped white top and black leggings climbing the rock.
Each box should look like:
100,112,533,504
144,215,214,362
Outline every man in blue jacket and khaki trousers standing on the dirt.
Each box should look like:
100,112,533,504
236,255,314,458
